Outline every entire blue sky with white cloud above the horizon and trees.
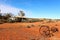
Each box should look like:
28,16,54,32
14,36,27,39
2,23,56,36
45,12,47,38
0,0,60,19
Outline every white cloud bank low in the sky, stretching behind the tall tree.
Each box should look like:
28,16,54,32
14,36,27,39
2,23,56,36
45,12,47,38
0,4,32,17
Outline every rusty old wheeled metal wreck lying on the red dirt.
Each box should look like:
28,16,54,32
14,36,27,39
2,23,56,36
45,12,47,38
39,25,58,37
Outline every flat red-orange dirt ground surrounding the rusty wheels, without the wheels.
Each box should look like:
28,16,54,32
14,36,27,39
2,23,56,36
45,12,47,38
0,22,60,40
